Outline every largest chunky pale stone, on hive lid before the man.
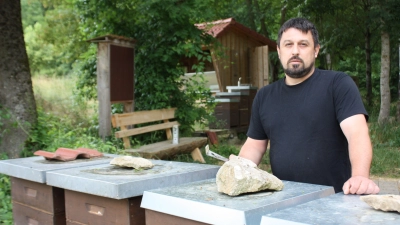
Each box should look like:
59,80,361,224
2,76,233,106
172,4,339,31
216,156,284,196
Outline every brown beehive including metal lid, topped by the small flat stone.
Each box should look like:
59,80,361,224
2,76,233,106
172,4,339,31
47,160,219,225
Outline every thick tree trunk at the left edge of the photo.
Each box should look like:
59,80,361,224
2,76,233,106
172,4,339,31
0,0,37,158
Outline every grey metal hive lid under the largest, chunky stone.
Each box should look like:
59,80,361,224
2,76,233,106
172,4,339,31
141,179,334,225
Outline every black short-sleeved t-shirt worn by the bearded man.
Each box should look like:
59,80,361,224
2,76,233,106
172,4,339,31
247,69,368,192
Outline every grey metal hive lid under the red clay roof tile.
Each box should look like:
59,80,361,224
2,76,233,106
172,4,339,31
0,154,116,183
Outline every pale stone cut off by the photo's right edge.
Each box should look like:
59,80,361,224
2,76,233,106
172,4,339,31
360,195,400,213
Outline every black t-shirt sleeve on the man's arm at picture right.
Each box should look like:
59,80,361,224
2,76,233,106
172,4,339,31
333,73,368,123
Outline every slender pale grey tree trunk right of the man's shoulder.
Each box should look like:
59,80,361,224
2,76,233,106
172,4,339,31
378,31,390,124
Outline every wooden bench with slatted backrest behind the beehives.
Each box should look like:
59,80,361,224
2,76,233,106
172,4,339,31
111,108,207,163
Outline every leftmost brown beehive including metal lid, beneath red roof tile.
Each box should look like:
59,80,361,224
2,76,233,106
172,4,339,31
0,154,113,225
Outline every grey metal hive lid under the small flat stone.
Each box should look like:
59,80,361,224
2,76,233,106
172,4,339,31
47,160,220,199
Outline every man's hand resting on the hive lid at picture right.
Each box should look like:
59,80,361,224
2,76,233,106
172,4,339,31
343,176,379,195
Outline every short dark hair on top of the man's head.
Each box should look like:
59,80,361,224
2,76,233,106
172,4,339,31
277,18,319,47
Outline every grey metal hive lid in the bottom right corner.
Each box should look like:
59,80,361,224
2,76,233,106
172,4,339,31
261,192,400,225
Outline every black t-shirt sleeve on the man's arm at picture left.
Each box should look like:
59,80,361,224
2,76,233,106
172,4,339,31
247,90,268,140
